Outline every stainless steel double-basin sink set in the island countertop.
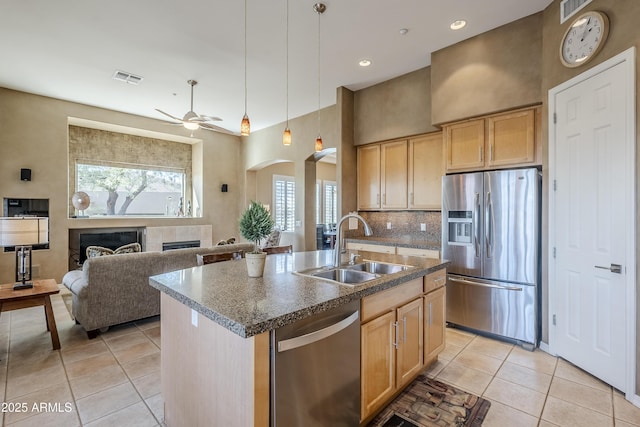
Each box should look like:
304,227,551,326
296,261,413,286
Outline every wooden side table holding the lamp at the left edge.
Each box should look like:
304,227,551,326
0,279,60,350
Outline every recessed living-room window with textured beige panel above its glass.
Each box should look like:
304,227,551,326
68,124,194,218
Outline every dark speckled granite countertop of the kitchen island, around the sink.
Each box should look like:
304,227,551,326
149,250,450,338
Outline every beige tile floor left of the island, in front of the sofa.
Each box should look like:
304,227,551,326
0,295,164,427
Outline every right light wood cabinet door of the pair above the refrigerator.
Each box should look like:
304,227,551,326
487,110,535,166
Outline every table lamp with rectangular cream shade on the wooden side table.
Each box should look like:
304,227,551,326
0,217,49,290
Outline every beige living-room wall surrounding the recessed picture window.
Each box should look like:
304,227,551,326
0,88,242,283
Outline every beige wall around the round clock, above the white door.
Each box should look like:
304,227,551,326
542,0,640,393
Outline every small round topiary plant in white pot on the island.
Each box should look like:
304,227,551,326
240,201,274,277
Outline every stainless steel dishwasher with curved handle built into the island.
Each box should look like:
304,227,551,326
271,301,360,427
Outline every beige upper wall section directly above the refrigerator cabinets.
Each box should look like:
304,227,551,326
431,13,542,124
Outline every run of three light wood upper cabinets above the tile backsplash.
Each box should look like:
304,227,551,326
358,132,444,210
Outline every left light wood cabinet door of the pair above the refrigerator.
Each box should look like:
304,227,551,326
445,119,484,171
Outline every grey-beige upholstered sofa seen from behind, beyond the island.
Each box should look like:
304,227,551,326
62,243,253,338
